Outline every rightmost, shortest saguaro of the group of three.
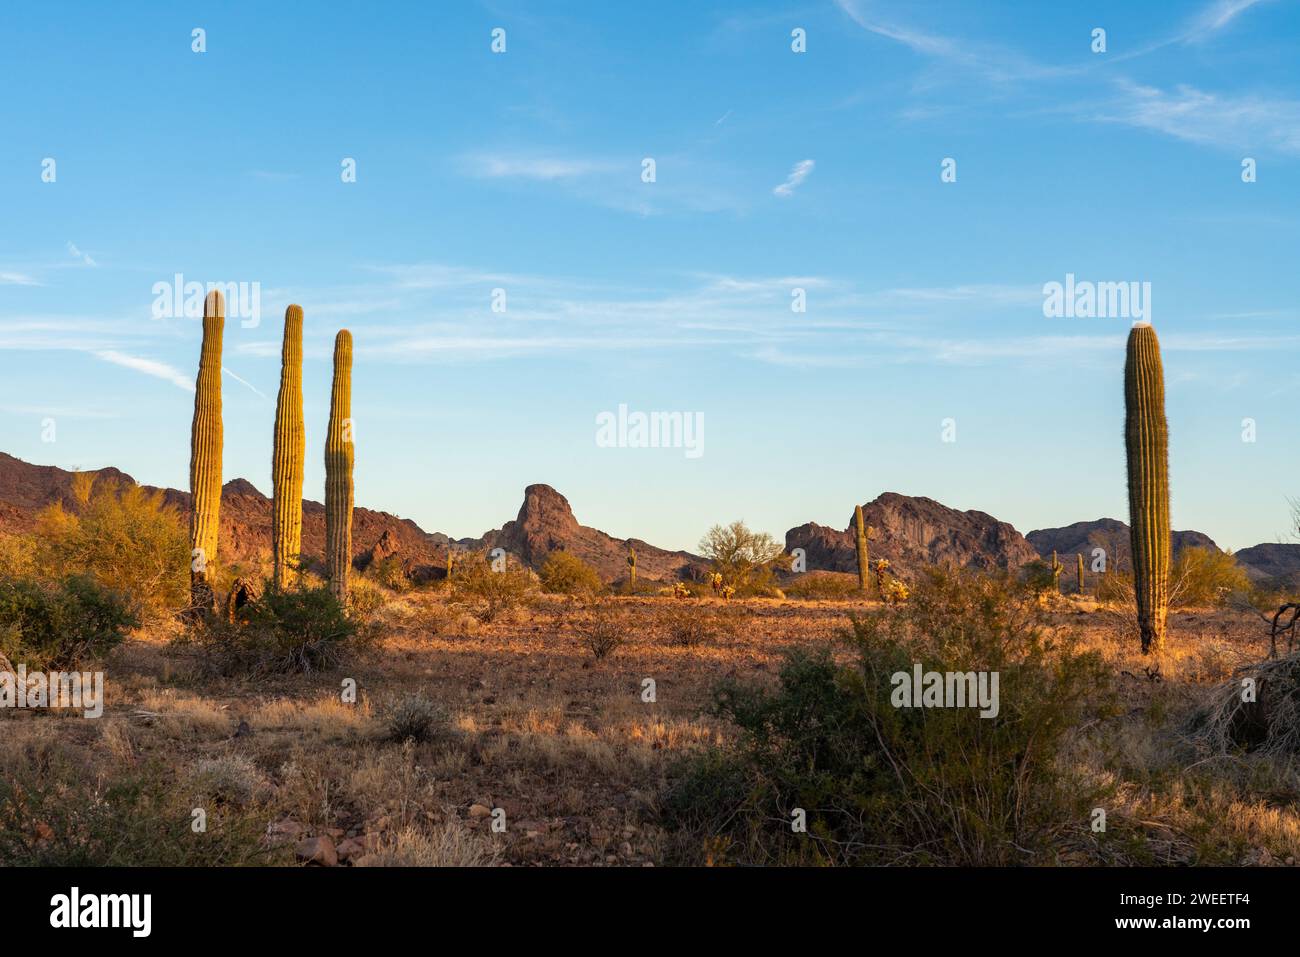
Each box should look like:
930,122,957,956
325,329,354,602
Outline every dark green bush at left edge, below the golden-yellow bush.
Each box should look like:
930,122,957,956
0,575,139,671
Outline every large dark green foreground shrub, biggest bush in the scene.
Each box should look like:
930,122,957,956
664,572,1110,865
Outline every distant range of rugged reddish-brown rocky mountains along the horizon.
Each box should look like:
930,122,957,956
0,452,1300,586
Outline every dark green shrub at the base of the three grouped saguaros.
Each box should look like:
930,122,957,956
178,588,373,676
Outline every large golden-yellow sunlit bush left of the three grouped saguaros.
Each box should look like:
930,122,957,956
35,473,190,620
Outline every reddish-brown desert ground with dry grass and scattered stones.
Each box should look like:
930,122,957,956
0,589,1300,866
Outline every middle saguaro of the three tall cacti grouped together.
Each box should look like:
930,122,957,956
270,306,307,589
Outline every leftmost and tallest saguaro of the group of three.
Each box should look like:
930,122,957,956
190,290,226,616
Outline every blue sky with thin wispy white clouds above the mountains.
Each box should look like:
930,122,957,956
0,0,1300,547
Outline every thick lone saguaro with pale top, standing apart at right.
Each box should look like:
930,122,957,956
1125,322,1171,654
